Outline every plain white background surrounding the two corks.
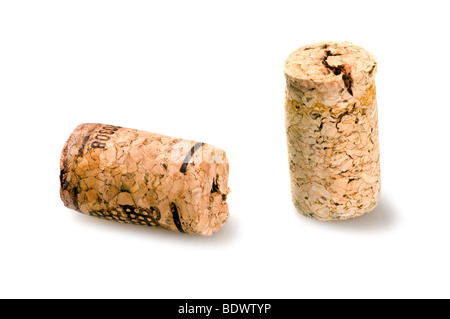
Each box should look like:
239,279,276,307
0,0,450,298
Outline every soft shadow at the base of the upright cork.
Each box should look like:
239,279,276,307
294,196,397,232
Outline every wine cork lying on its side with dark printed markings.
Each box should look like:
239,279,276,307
60,124,230,235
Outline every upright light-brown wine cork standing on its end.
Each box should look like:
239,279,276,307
284,42,380,221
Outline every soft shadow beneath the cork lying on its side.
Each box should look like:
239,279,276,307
68,209,237,245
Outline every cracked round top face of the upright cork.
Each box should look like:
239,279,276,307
284,42,377,83
